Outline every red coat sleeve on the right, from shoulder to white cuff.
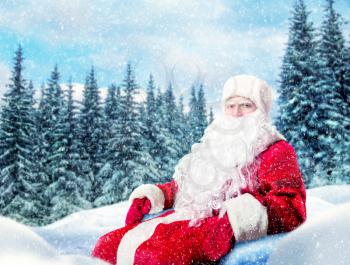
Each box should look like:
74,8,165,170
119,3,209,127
253,141,306,234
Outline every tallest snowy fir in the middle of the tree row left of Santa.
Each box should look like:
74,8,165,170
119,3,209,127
96,64,157,202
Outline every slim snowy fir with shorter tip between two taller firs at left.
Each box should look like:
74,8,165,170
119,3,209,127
45,77,90,222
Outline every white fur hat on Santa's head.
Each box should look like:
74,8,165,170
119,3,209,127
222,75,275,117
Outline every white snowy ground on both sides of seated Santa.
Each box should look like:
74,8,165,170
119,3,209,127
0,185,350,265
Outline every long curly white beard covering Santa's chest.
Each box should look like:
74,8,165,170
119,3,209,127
173,110,283,226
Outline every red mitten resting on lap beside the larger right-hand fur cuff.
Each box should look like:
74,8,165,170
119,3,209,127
202,213,235,261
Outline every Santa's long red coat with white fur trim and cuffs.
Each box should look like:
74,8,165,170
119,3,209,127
92,140,306,265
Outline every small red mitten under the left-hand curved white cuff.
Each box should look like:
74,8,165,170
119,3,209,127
125,197,151,225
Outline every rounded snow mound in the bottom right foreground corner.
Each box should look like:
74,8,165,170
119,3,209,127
268,203,350,265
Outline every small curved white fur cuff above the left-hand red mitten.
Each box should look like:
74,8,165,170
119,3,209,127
129,184,165,213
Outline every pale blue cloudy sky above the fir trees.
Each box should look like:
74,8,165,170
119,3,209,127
0,0,350,112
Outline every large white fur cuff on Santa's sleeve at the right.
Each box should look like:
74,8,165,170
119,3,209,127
224,193,268,242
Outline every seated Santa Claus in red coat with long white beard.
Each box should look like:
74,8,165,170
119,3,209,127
92,75,306,265
